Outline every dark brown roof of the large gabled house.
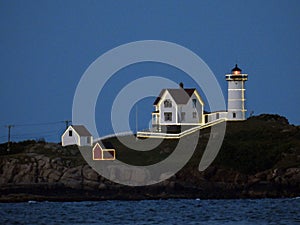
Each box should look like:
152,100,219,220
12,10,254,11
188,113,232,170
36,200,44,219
153,88,196,105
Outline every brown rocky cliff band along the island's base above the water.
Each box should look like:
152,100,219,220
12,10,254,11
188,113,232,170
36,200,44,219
0,149,300,201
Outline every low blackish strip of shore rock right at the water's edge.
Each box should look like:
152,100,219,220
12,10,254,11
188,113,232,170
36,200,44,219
0,178,300,203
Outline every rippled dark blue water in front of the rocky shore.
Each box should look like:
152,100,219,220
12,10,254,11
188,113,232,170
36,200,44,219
0,198,300,225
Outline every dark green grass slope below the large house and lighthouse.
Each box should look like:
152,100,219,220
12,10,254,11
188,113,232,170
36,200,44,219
105,115,300,174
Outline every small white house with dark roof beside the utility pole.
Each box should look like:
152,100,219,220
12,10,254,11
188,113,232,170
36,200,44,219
61,125,93,146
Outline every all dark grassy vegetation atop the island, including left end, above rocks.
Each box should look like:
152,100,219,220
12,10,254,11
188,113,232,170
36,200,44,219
0,114,300,174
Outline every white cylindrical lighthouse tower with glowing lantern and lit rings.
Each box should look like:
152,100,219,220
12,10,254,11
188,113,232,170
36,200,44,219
226,64,248,121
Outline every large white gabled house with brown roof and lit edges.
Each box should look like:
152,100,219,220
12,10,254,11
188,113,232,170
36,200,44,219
152,83,204,131
